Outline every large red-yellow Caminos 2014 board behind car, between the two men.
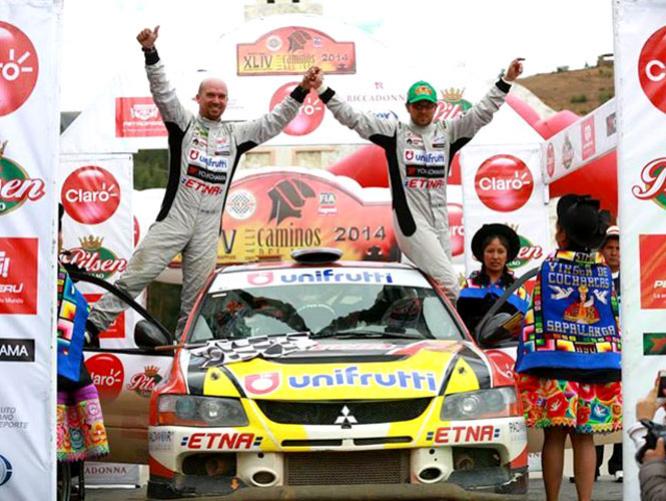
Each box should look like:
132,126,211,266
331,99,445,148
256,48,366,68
218,171,399,263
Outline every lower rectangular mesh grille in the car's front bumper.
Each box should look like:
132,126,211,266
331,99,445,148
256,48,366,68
284,450,409,485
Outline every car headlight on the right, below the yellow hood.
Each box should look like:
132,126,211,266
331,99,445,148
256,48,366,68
440,386,520,421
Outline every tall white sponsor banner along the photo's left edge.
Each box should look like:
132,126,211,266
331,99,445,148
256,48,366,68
0,0,61,500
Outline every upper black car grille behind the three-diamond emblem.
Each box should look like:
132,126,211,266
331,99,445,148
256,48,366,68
256,397,431,425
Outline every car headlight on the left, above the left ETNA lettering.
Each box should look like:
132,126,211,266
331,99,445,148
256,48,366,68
157,395,248,426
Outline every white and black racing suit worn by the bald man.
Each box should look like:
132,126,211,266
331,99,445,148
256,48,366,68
89,51,308,335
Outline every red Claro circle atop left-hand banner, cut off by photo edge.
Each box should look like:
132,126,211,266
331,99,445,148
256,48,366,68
0,21,39,116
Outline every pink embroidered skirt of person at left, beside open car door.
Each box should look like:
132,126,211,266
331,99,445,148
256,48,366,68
57,384,109,461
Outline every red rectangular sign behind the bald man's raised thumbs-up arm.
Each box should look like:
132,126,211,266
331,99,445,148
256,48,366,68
116,97,167,137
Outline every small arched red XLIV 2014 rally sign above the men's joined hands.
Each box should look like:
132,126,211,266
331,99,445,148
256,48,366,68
236,26,356,76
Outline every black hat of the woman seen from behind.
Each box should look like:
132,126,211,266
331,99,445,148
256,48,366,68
557,194,610,249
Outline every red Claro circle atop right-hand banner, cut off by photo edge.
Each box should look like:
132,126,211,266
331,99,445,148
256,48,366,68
638,26,666,113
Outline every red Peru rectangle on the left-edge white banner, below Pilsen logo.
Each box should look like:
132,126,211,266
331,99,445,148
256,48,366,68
0,238,38,315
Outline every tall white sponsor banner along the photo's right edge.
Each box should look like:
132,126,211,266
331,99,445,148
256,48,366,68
614,0,666,499
